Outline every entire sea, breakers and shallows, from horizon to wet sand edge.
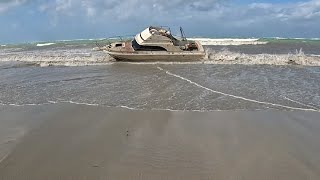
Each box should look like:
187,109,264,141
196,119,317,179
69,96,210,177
0,38,320,111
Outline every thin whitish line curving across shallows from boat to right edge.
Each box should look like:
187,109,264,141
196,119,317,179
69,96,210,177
157,66,320,112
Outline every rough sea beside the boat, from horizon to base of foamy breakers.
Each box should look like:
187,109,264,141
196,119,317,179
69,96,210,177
0,38,320,66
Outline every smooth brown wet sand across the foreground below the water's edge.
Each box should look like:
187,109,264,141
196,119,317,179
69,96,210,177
0,103,320,180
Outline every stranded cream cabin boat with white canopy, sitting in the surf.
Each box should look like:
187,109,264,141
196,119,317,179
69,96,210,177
104,26,205,61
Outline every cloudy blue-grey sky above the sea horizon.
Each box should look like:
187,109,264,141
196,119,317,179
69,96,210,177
0,0,320,43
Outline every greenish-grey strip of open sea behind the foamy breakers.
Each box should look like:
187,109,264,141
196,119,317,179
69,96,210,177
0,38,320,52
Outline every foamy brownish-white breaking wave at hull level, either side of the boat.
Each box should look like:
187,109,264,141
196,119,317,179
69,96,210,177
0,47,320,66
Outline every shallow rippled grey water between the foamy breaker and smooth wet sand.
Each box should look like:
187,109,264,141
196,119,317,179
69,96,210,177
0,63,320,111
